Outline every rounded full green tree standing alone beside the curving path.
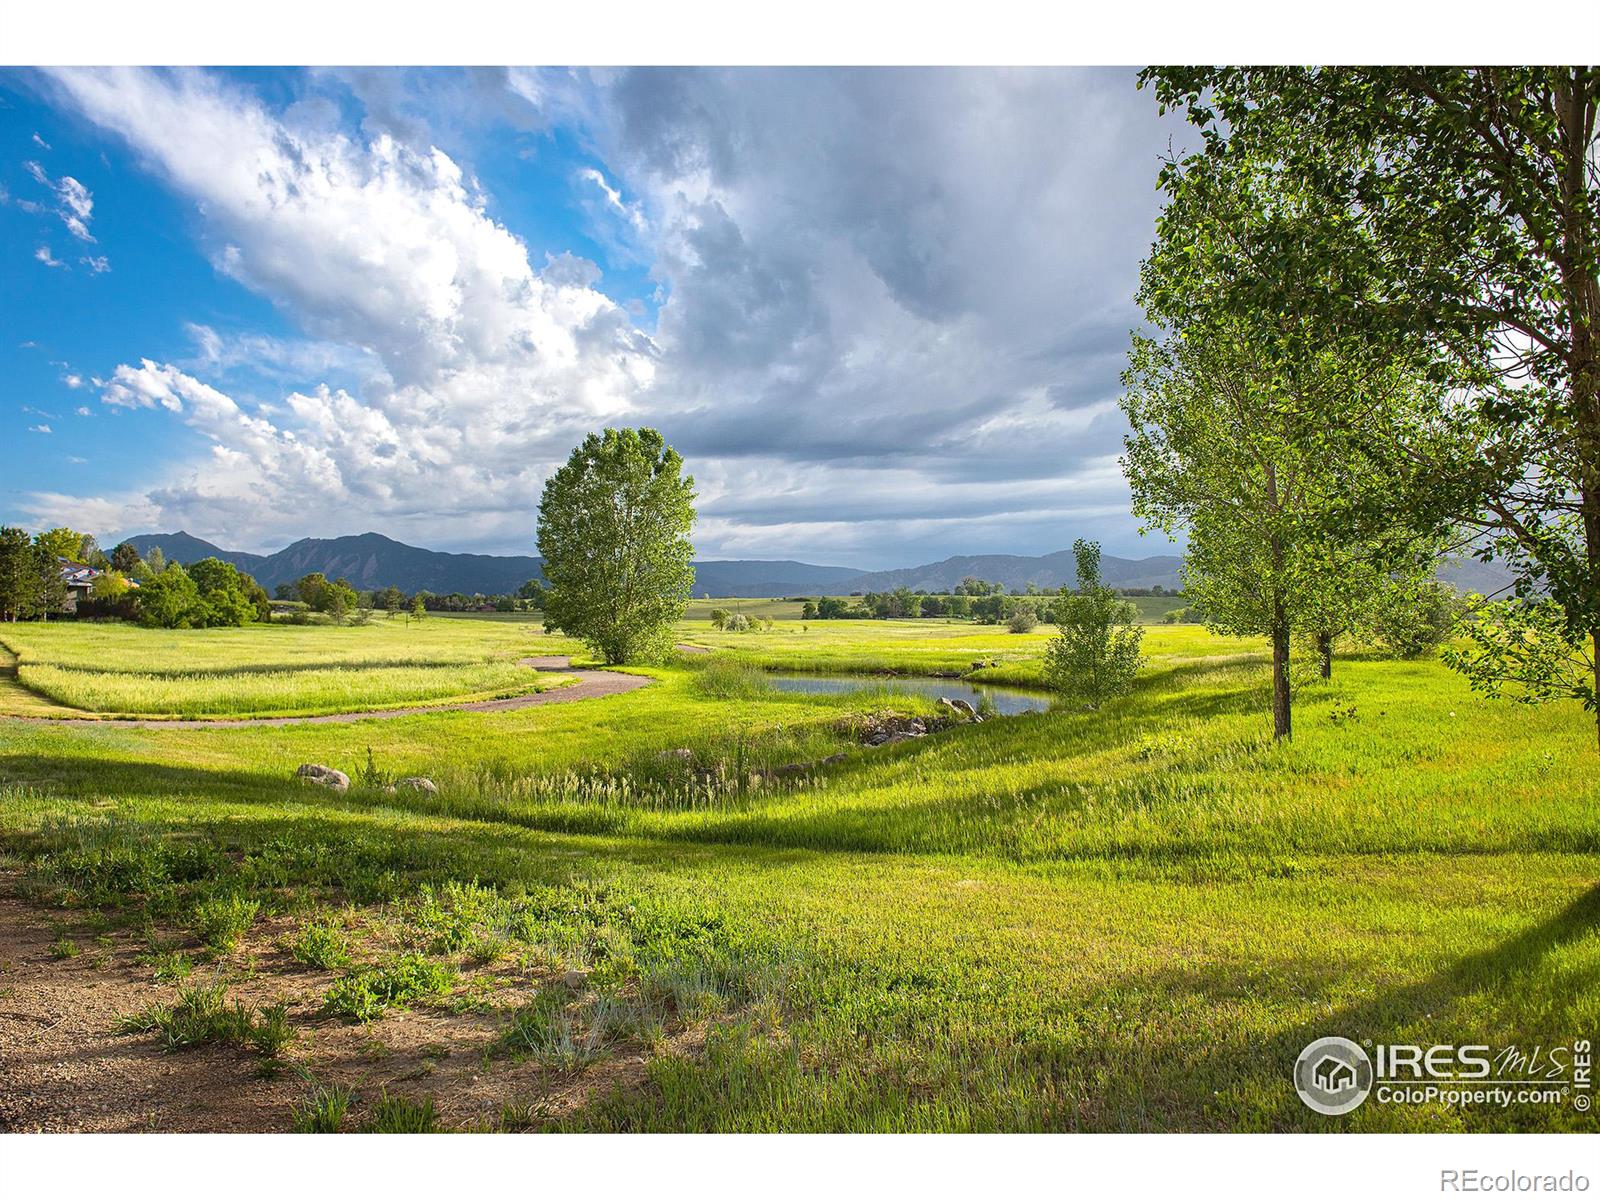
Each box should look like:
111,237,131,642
539,429,694,662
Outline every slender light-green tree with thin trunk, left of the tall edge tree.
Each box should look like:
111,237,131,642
1123,129,1475,738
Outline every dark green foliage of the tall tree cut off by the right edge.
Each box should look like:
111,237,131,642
1141,66,1600,742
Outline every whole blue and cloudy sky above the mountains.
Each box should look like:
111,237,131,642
0,69,1182,570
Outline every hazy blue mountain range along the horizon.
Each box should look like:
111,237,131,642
126,530,1507,597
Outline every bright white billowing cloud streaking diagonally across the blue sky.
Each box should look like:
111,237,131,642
39,70,656,546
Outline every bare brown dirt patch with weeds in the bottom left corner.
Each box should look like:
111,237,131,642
0,898,704,1133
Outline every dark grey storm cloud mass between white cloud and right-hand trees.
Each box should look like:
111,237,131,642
544,69,1171,552
